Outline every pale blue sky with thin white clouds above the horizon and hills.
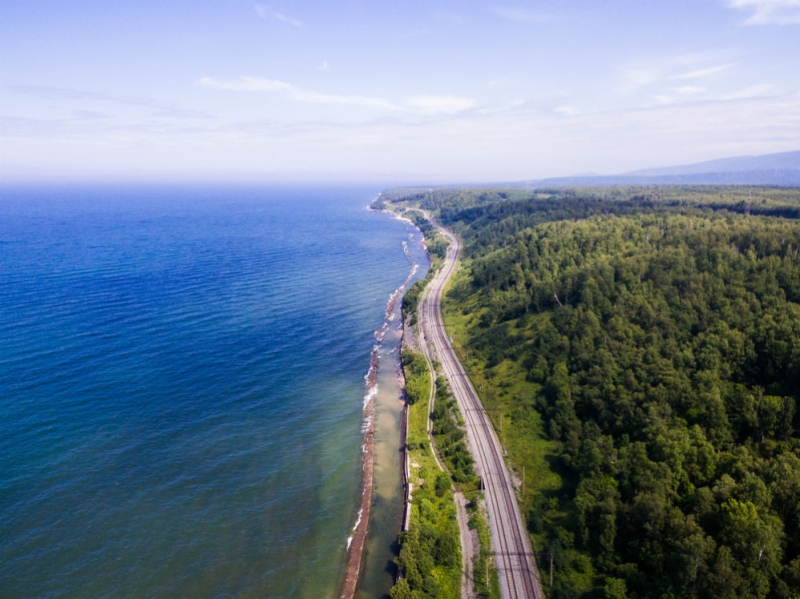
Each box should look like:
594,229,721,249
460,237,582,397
0,0,800,184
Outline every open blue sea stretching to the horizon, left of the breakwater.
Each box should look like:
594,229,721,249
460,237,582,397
0,187,424,599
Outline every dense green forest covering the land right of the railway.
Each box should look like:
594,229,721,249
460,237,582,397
386,187,800,599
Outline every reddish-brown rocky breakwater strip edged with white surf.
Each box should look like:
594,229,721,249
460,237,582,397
340,208,427,599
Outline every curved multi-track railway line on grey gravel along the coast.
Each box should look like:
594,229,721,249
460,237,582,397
420,215,543,599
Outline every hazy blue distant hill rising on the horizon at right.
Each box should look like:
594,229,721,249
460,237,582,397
523,151,800,187
